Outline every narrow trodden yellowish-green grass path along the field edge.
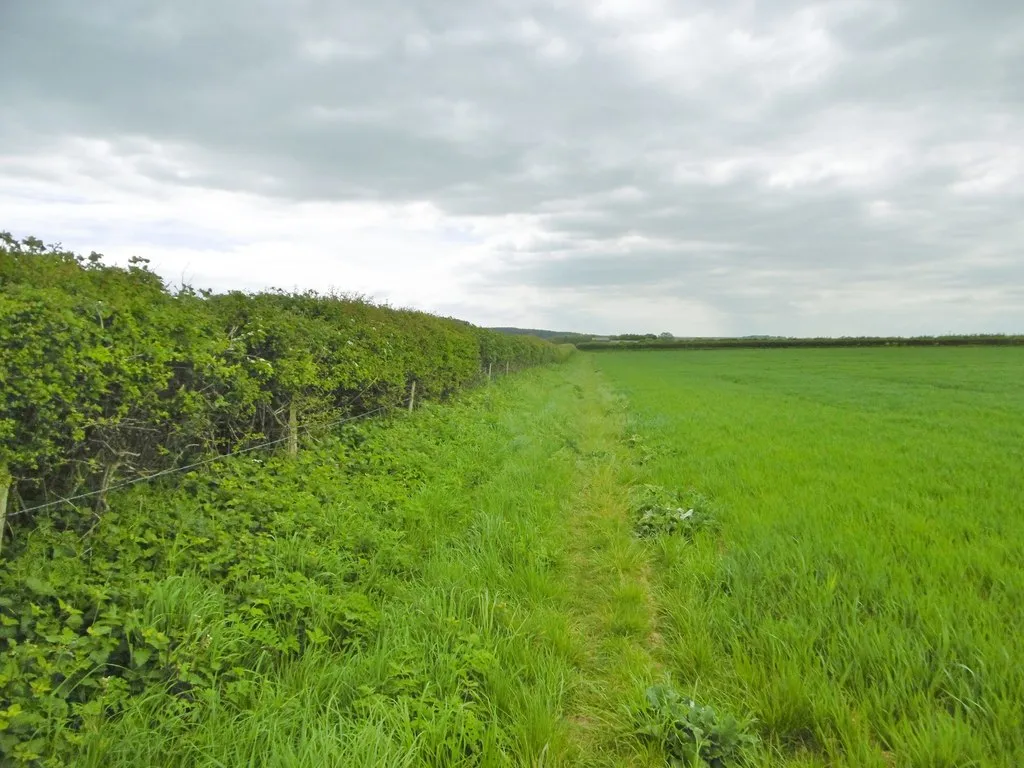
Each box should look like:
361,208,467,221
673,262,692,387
566,365,659,766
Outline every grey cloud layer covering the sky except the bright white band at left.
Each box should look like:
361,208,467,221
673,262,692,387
0,0,1024,332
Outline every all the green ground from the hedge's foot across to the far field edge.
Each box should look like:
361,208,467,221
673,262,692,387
0,348,1024,768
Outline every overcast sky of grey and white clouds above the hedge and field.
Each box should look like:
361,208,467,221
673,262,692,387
0,0,1024,336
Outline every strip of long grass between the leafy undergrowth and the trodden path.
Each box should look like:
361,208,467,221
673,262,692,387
51,372,589,767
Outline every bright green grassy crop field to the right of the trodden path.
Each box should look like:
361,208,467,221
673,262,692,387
596,348,1024,766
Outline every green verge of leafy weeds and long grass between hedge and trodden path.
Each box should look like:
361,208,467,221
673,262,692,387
0,362,655,766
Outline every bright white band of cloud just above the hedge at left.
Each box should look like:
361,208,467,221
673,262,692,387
0,142,507,309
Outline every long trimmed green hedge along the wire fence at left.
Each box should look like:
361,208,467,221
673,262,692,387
0,232,565,536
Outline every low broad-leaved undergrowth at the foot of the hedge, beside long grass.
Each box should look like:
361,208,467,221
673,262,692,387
0,388,494,768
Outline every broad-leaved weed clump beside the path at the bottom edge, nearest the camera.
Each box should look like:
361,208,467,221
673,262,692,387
637,683,757,768
